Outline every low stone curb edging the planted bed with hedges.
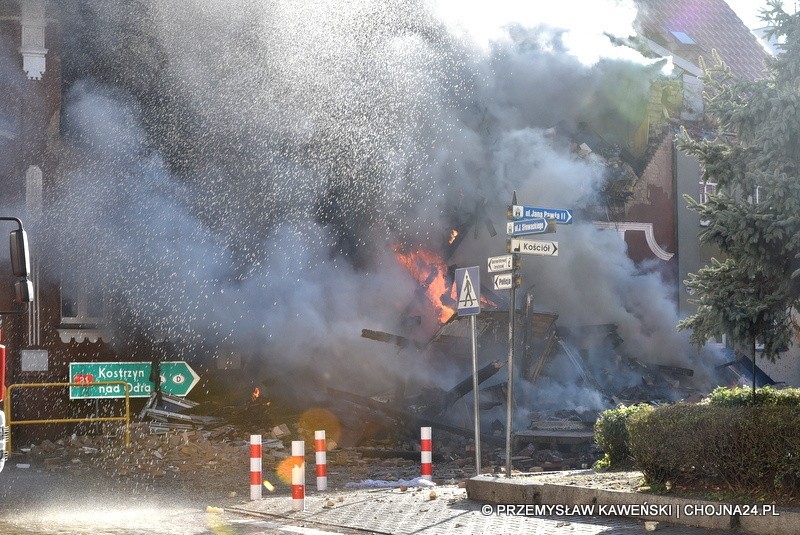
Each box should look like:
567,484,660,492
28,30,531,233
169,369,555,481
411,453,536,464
467,476,800,535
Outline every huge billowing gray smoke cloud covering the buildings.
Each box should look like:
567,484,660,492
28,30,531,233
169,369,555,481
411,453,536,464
39,0,724,406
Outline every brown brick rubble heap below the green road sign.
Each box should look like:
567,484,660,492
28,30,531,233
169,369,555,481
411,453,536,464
22,394,297,489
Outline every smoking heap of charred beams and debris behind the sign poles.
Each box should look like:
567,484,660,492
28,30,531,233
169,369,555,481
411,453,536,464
346,286,716,470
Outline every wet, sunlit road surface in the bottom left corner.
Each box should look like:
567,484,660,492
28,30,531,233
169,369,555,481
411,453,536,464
0,462,352,535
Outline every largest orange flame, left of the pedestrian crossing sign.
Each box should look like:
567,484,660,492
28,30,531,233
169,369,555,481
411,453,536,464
393,244,456,323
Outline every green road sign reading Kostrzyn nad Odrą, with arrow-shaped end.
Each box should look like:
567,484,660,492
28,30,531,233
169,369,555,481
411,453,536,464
69,360,200,399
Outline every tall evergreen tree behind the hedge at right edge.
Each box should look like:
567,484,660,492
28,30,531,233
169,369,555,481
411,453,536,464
678,0,800,358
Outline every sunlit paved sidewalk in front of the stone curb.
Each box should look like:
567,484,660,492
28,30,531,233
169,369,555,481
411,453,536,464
226,485,730,535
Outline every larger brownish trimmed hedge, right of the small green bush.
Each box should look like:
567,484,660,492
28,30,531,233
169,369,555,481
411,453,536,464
627,404,800,496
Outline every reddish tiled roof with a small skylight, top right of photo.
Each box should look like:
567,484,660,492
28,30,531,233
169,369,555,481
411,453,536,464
636,0,767,80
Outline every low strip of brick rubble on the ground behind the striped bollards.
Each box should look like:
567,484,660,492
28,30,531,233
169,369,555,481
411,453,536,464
23,422,493,492
